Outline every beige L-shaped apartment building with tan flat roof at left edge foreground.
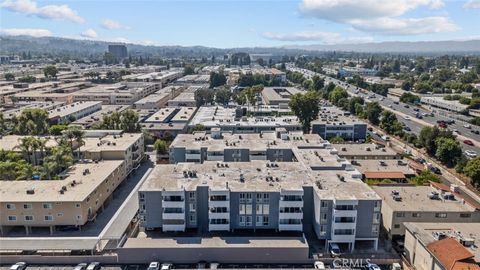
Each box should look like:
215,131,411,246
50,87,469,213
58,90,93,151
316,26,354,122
0,160,127,235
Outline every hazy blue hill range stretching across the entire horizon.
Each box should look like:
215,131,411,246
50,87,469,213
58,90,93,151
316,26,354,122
0,35,480,58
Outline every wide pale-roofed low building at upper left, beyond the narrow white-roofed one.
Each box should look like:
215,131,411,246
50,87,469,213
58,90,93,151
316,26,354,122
73,82,162,105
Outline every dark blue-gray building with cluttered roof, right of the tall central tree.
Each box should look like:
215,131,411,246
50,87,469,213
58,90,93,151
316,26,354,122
312,107,367,141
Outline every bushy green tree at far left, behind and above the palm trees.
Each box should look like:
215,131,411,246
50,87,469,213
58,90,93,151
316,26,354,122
14,108,48,135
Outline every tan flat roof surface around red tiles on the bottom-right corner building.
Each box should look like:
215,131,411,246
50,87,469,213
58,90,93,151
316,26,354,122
404,222,480,263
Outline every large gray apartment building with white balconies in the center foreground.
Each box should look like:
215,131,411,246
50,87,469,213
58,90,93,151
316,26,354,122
139,133,381,250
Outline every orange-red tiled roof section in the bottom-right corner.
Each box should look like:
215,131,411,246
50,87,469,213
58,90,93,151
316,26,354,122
427,237,478,270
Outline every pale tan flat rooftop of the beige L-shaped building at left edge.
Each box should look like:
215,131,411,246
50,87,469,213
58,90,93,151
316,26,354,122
0,160,124,202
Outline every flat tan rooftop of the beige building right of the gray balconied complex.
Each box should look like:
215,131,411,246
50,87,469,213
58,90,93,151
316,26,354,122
372,185,475,212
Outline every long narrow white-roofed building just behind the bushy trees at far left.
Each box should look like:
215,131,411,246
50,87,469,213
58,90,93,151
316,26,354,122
48,101,102,123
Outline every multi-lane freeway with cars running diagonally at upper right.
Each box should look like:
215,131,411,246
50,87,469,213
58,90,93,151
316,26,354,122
287,66,480,154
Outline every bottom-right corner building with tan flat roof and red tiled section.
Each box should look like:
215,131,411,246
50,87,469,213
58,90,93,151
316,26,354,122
405,222,480,270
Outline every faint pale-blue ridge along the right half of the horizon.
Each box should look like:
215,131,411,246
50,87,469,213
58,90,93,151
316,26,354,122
283,40,480,54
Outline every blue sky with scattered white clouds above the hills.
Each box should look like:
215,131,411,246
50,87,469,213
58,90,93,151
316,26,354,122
0,0,480,48
